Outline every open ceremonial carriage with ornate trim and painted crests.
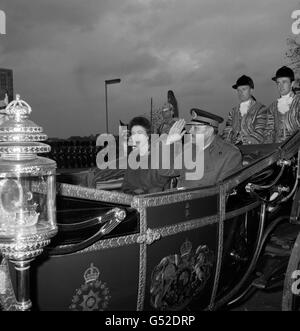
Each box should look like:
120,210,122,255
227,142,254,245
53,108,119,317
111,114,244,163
0,132,300,311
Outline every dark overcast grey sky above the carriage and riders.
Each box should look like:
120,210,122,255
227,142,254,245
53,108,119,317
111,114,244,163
0,0,300,137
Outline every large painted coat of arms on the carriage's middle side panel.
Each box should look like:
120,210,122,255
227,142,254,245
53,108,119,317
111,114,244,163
150,240,214,310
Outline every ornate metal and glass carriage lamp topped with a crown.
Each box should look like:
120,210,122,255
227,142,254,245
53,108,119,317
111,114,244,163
0,95,57,310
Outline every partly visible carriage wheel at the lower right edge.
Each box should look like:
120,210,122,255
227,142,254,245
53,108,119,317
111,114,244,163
282,233,300,311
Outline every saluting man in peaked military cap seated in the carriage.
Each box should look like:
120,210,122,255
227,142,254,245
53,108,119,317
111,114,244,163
168,108,242,188
